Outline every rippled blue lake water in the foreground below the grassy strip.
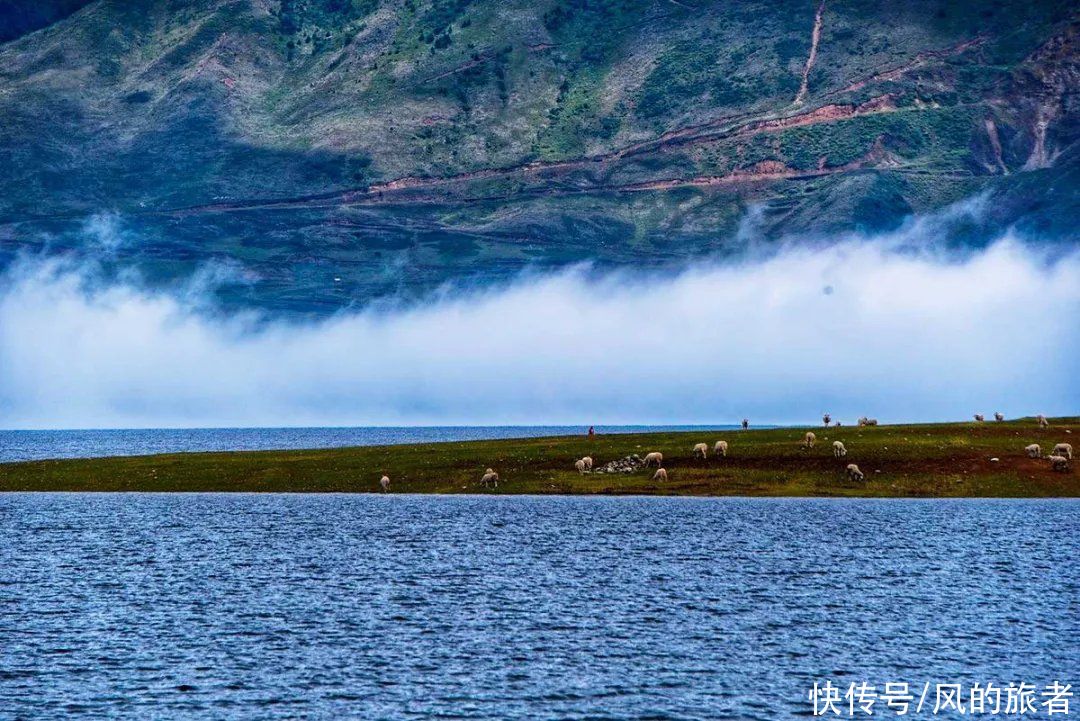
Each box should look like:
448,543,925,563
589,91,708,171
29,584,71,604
0,493,1080,720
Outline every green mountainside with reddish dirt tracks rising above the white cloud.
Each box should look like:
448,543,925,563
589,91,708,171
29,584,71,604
0,0,1080,313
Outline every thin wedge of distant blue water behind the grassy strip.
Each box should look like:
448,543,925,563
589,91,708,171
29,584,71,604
0,424,743,463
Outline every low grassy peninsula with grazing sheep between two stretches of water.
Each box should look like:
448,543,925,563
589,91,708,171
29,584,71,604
0,418,1080,498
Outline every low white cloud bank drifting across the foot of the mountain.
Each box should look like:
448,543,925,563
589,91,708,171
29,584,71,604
0,239,1080,427
